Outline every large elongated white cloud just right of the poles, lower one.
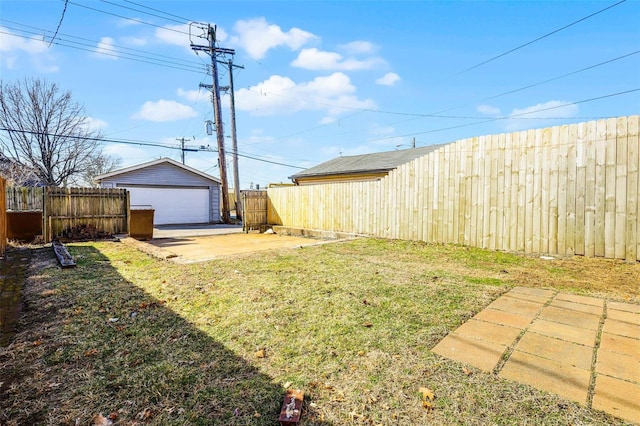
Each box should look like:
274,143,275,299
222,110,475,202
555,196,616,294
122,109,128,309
236,72,376,121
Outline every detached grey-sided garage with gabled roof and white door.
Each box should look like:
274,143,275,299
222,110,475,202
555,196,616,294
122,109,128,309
94,158,220,225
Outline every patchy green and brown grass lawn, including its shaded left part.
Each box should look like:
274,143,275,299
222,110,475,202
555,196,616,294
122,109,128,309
0,239,640,425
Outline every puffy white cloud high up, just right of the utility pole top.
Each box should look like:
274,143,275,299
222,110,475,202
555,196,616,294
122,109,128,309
230,18,318,60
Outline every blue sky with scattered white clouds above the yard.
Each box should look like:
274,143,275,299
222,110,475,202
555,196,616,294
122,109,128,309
0,0,640,189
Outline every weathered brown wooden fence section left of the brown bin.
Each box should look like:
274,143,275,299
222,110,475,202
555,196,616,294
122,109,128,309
42,187,129,242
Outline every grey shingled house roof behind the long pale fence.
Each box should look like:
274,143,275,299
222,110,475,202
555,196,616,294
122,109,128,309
289,145,444,181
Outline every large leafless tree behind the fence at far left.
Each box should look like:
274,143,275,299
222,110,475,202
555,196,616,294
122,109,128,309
0,79,115,186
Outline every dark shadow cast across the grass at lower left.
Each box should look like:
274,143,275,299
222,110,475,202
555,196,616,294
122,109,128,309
0,246,330,426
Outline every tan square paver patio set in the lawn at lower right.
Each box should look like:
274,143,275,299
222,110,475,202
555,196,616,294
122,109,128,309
433,287,640,423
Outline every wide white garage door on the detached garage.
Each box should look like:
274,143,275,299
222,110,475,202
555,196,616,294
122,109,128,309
127,187,209,225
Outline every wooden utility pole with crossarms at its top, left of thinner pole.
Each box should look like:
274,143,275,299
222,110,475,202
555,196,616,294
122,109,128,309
191,24,235,223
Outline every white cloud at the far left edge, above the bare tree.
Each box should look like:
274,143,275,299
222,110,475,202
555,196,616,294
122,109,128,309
0,26,59,73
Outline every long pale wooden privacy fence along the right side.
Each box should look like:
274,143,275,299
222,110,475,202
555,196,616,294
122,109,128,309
268,116,640,262
